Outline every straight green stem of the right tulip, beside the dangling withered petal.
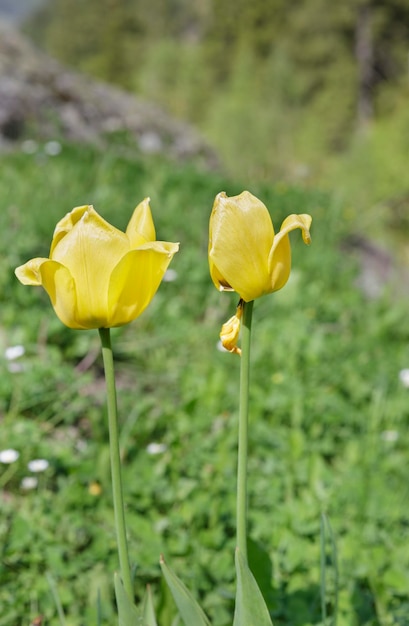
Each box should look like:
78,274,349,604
237,301,253,562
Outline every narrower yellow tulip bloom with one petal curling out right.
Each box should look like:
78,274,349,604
209,191,312,302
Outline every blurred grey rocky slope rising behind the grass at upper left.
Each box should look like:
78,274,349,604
0,21,216,165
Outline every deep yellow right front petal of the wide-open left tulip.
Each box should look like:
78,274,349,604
107,241,179,327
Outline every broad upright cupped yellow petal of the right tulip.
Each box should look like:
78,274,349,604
209,191,274,302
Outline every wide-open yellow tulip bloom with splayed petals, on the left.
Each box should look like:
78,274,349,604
15,198,179,329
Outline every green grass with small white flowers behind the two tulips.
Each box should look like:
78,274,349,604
0,139,409,626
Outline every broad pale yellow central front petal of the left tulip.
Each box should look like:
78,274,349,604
52,207,129,328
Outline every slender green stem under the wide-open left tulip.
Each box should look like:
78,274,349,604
99,328,134,601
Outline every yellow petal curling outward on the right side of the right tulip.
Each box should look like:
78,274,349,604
268,214,312,291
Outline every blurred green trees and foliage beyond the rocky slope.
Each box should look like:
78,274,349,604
26,0,409,207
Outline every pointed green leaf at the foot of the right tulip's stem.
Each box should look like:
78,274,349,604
233,548,273,626
